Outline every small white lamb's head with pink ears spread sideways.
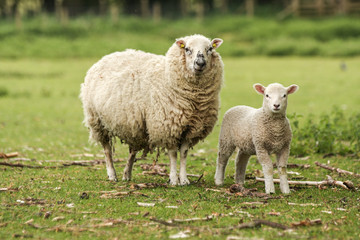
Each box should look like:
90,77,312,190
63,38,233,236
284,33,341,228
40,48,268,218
254,83,299,114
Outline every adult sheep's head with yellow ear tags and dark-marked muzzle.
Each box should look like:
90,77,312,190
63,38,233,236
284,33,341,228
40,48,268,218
176,35,223,75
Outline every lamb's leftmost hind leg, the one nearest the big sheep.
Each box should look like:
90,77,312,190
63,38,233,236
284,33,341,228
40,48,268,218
215,141,235,186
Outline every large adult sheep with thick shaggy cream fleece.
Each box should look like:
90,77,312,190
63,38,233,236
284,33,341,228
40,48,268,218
80,35,224,185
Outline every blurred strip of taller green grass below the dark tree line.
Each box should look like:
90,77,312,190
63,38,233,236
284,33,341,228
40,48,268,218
0,15,360,58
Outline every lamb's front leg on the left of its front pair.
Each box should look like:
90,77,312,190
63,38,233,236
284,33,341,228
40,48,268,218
256,149,275,194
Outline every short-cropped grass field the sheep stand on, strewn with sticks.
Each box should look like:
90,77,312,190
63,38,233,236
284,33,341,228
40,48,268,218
0,56,360,239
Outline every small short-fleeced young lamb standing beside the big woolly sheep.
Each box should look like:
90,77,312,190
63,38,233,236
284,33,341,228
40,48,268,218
215,83,299,193
